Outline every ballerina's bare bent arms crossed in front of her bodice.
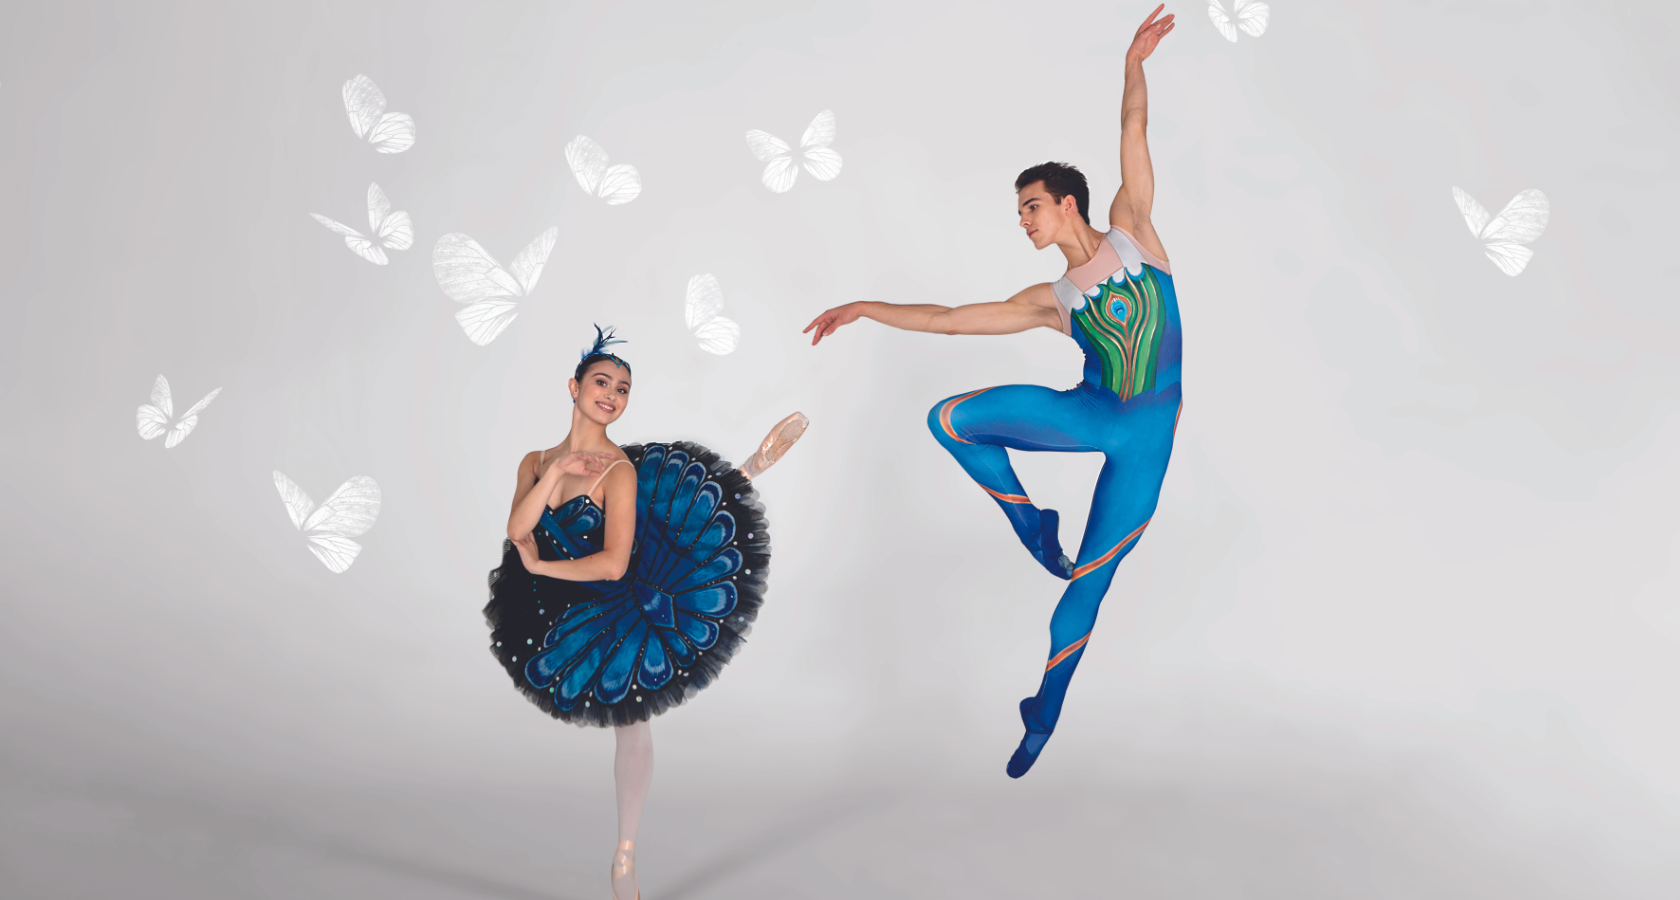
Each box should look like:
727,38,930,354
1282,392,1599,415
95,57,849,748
507,452,637,581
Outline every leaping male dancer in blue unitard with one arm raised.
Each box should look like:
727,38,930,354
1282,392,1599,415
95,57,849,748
805,5,1183,777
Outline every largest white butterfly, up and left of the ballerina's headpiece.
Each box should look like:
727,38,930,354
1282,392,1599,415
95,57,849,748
432,228,559,346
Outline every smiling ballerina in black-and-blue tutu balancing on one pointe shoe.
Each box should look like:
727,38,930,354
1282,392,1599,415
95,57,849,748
484,327,810,900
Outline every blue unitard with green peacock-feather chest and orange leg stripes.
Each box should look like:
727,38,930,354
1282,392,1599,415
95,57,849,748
927,228,1183,777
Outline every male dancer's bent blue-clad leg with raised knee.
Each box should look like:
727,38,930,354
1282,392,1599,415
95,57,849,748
927,385,1097,579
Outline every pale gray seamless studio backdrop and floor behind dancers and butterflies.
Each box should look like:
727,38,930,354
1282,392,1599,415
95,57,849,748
0,0,1680,900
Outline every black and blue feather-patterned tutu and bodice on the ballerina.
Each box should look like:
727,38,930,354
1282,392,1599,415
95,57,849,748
484,442,769,727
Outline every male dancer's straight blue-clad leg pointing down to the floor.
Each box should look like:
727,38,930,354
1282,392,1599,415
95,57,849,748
1008,406,1173,777
